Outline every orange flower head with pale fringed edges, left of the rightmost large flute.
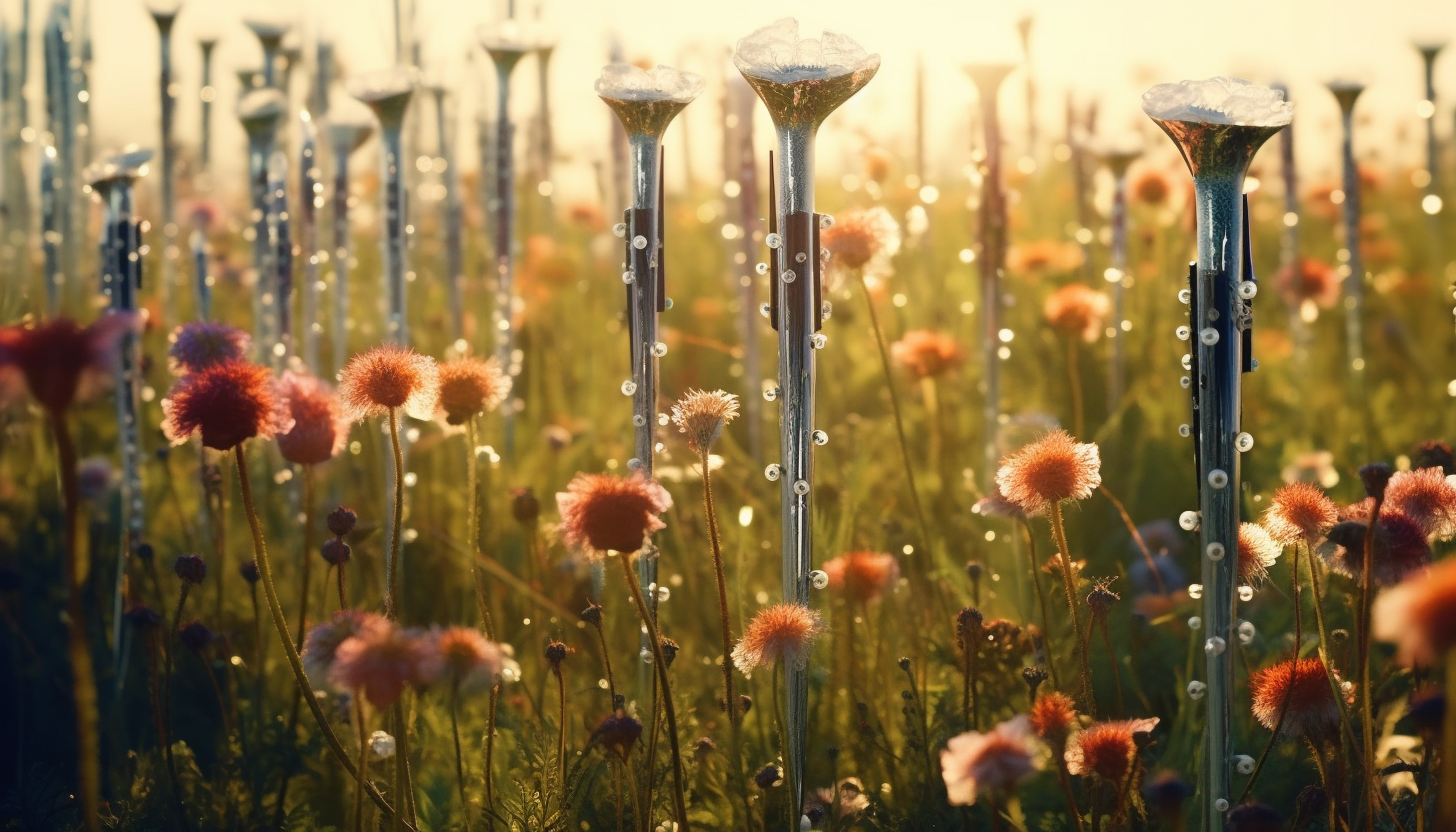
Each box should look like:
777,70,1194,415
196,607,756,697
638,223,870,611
996,430,1102,514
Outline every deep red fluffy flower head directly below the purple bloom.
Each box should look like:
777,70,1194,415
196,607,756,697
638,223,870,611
162,361,293,450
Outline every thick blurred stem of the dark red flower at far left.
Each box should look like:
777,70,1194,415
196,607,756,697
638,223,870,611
50,411,101,832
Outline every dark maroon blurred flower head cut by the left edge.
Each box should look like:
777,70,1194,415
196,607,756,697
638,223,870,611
0,312,137,414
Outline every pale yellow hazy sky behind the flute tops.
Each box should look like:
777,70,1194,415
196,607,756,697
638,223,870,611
28,0,1456,202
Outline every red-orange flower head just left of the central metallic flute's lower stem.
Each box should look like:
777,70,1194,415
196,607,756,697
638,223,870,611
556,474,673,558
